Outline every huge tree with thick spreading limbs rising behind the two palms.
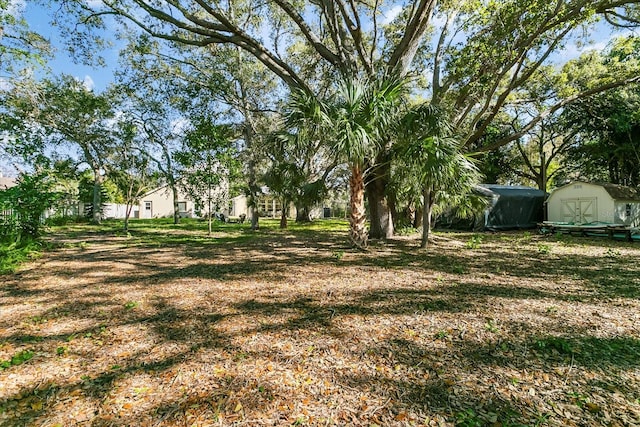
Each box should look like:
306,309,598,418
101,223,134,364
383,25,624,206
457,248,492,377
47,0,640,241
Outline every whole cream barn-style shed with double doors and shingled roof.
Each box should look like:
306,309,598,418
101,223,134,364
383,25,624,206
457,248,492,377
547,181,640,227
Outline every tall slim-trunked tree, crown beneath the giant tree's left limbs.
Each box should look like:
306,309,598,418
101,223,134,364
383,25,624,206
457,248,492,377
117,32,278,229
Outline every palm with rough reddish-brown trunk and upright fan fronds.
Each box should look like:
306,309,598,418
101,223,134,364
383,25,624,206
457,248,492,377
287,79,406,249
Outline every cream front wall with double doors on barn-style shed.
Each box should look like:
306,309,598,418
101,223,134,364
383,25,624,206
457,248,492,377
547,182,616,223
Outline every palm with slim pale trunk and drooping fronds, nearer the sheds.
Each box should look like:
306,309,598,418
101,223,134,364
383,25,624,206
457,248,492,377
397,104,480,248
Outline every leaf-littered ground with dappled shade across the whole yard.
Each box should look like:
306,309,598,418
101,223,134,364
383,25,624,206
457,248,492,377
0,225,640,426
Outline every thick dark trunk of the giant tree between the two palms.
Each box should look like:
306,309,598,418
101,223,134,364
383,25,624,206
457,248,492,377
367,154,393,239
